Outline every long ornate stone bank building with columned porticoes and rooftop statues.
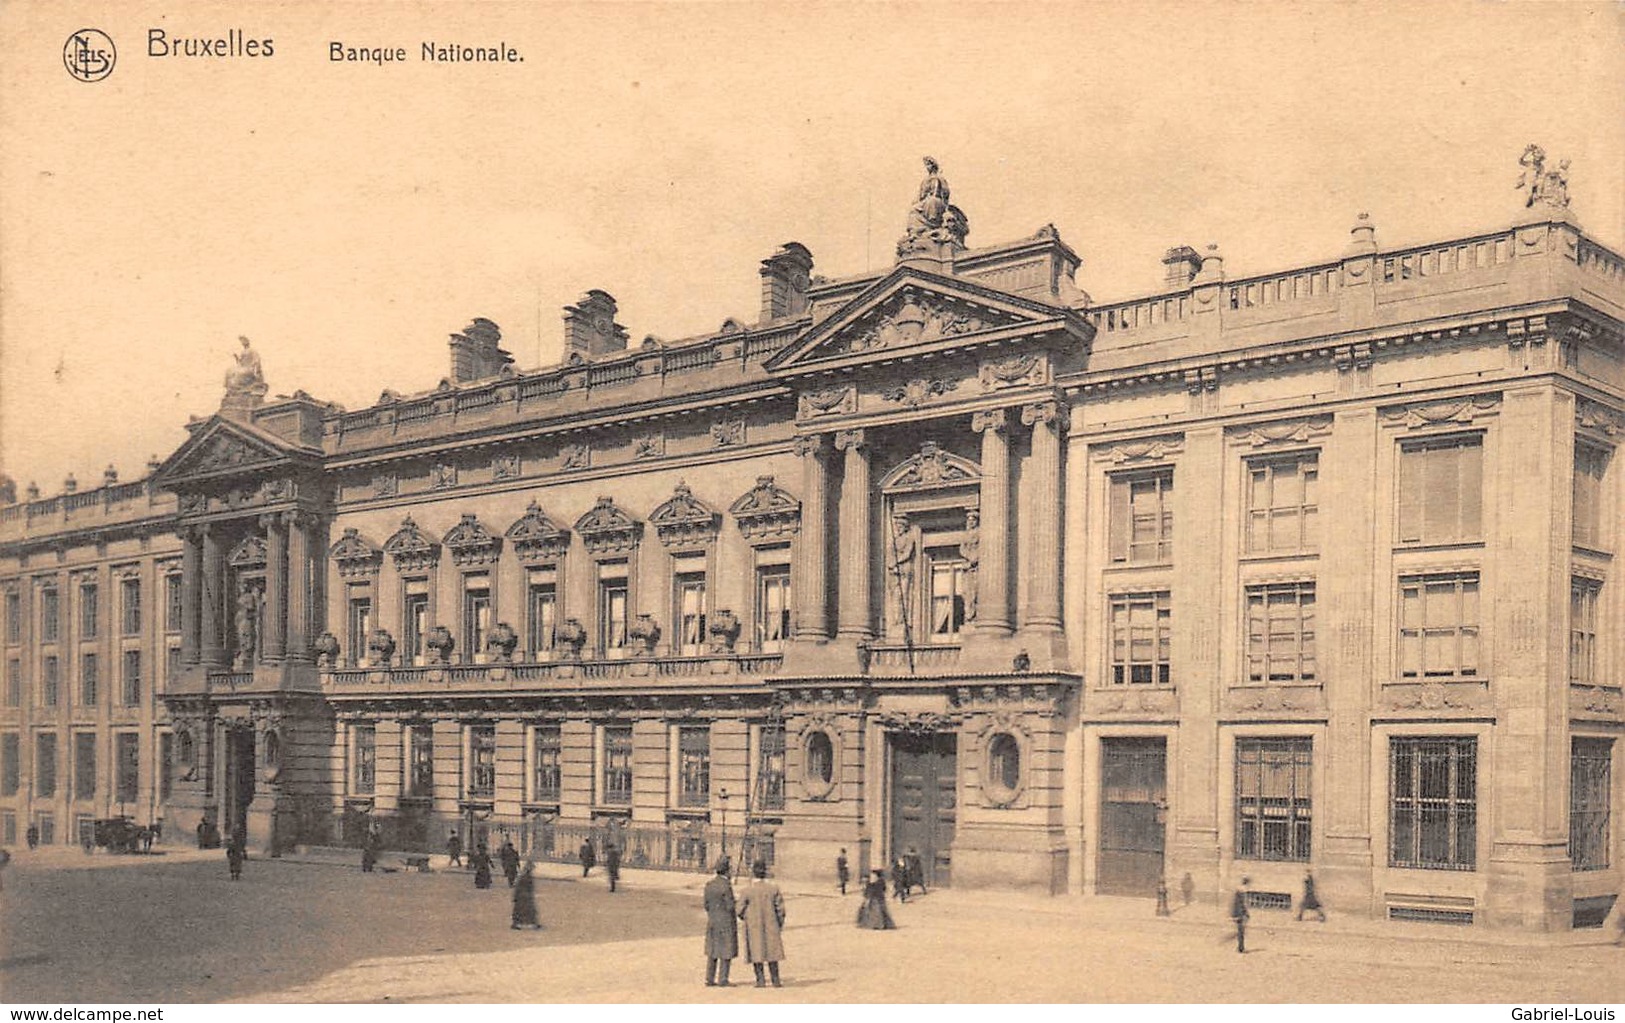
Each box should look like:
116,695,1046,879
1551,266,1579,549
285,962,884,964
0,149,1625,930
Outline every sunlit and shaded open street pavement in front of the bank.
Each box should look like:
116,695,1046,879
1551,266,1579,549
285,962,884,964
0,851,1625,1005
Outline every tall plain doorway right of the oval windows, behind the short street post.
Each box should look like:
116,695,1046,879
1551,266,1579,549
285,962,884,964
1095,739,1168,895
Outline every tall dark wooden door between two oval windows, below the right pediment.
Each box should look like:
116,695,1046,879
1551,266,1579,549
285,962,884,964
891,732,959,887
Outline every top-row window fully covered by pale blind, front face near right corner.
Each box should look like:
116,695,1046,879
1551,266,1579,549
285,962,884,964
1399,435,1484,544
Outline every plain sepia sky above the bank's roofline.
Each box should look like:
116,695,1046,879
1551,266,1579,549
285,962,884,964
0,0,1625,495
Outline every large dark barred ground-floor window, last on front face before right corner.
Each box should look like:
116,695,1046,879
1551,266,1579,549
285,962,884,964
1388,736,1479,870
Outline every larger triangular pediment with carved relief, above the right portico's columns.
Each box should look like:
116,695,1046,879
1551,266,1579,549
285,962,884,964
767,266,1076,372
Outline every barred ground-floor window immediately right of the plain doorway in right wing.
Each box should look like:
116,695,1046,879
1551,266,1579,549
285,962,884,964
1235,739,1313,862
